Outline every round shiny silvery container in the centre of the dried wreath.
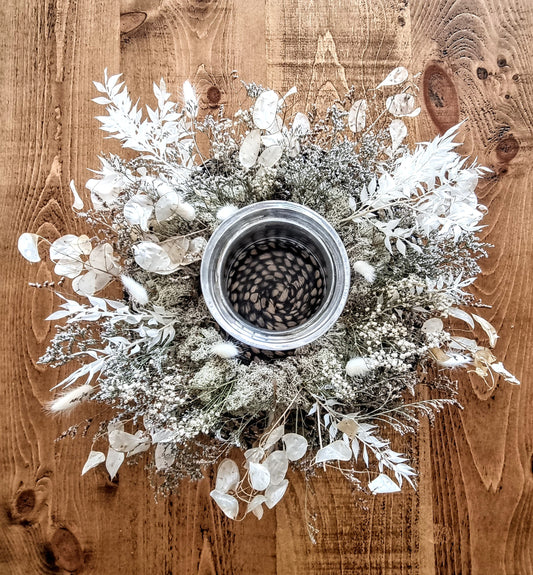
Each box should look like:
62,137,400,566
200,201,350,351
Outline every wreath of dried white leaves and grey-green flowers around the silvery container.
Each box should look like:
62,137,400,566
18,67,519,519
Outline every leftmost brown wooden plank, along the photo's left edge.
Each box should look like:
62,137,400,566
0,1,118,575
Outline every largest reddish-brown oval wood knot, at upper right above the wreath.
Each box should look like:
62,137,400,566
422,64,459,134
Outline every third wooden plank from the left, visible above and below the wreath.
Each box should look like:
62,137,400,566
267,0,419,574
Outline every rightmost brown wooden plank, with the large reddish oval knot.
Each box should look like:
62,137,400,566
410,0,533,575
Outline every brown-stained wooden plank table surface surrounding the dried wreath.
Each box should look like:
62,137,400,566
0,0,533,575
